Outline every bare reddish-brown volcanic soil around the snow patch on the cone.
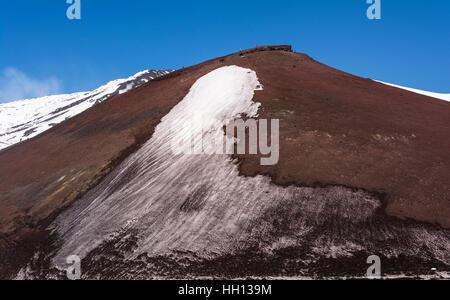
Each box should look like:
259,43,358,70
0,47,450,277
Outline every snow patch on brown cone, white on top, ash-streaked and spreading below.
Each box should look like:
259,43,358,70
40,66,449,279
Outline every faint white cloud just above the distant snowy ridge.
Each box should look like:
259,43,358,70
0,68,62,102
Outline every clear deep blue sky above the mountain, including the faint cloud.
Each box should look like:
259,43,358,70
0,0,450,102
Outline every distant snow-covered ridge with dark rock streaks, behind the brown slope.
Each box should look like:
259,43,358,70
0,70,170,150
